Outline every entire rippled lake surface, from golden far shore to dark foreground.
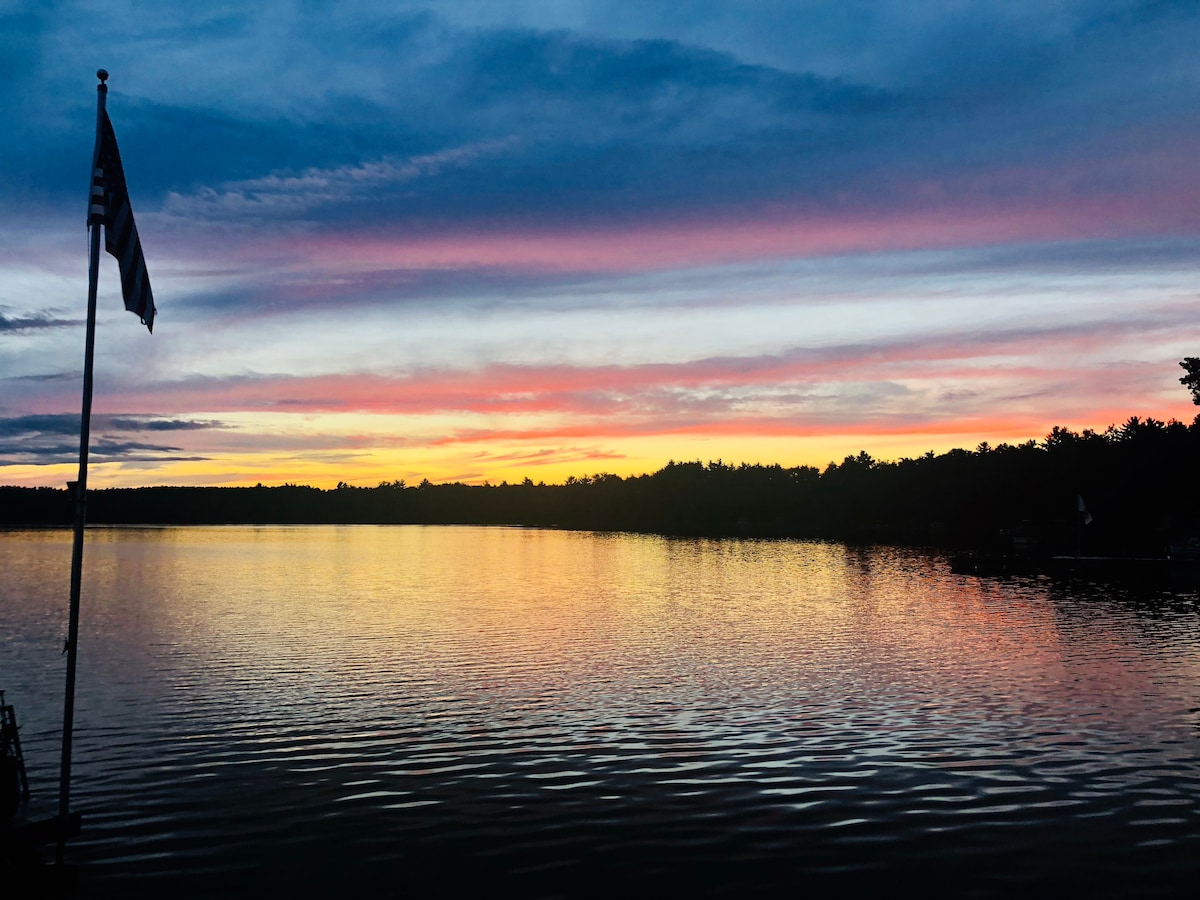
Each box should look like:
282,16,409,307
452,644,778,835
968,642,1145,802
0,527,1200,900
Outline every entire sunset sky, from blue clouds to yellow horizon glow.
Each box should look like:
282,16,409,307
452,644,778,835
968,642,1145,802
0,0,1200,487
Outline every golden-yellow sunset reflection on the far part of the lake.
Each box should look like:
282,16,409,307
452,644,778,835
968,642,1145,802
9,526,1200,748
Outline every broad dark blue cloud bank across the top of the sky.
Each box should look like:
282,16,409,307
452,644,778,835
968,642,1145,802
9,0,1200,241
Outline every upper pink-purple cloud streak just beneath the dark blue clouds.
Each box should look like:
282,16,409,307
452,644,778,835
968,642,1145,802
265,142,1200,278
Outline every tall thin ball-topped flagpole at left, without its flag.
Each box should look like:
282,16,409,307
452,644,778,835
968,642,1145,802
58,68,108,863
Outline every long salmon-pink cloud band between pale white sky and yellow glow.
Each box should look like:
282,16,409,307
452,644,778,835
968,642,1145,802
87,326,1174,422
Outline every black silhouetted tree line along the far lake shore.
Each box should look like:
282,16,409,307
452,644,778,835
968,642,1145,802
7,416,1200,556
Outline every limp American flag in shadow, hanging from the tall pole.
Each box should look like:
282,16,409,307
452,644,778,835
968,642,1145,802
88,112,155,332
